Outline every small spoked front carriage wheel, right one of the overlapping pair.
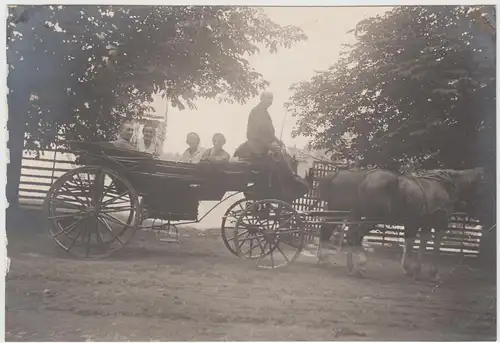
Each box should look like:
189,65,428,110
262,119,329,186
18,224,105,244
234,199,305,268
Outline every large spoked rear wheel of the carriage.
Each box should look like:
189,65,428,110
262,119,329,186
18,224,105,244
44,166,141,257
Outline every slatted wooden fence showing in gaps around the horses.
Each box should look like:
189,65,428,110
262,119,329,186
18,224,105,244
294,161,482,256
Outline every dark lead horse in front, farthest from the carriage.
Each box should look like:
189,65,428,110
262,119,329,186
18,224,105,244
398,167,486,280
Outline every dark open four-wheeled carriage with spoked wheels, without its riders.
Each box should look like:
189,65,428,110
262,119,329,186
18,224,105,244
44,142,307,268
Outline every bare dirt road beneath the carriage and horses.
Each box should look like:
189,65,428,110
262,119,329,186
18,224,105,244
5,214,496,341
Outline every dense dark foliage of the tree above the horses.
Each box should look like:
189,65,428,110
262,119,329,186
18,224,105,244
287,6,496,172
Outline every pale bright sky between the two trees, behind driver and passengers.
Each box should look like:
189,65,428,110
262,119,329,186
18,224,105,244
153,7,390,154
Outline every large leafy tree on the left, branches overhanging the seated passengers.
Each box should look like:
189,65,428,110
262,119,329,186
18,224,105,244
7,6,306,208
